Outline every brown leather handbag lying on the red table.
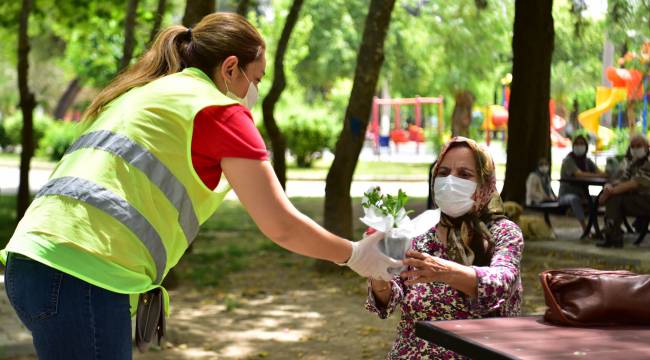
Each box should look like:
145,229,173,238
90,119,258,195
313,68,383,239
539,268,650,326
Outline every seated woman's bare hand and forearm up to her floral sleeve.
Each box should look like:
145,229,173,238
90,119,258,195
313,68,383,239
400,250,478,297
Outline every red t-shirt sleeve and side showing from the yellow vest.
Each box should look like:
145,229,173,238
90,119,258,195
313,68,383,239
192,105,268,189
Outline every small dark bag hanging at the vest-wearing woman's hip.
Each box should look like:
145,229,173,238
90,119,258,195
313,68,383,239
135,288,165,352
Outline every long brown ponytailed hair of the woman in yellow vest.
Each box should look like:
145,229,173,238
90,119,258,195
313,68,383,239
83,13,266,120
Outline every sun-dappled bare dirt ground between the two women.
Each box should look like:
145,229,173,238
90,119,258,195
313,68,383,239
135,252,397,360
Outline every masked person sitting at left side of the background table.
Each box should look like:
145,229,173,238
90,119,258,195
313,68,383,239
559,134,605,235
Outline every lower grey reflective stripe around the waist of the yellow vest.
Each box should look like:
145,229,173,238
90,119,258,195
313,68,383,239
36,176,167,284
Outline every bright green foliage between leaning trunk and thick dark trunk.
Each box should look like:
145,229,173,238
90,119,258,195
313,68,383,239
382,0,513,105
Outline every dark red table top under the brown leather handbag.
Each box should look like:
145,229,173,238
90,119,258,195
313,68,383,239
416,316,650,360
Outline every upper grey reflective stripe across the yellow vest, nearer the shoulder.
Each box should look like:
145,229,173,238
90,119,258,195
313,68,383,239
66,130,199,244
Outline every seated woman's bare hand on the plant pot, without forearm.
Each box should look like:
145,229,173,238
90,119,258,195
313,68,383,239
400,250,459,285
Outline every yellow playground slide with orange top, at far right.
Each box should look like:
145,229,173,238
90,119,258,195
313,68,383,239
578,66,647,150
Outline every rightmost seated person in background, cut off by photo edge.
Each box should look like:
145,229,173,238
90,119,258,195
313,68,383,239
597,134,650,248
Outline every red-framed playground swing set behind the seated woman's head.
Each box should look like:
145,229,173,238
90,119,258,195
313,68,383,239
370,96,443,152
